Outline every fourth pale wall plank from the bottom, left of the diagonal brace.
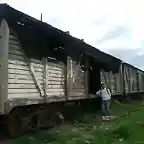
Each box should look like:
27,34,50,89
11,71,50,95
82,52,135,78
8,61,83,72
8,79,35,84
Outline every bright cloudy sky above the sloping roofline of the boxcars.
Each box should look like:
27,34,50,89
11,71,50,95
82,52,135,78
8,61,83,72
0,0,144,69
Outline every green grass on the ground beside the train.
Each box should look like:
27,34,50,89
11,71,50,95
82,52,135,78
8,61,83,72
8,101,144,144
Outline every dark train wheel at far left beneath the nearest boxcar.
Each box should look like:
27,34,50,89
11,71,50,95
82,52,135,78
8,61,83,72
7,112,23,137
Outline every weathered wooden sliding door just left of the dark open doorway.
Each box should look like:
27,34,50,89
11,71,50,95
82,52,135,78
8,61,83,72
67,56,86,100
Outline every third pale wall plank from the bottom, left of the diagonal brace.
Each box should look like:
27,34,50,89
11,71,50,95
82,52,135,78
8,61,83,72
8,83,36,89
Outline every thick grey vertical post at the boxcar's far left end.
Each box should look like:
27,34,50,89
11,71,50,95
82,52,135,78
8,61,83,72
0,19,9,113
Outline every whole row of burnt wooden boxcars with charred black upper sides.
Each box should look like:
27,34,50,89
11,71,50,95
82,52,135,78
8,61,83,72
0,4,144,136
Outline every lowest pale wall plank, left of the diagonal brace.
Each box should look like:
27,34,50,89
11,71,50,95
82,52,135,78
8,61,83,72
8,92,40,99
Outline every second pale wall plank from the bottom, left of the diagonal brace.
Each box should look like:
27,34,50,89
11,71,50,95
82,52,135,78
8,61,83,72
8,89,39,94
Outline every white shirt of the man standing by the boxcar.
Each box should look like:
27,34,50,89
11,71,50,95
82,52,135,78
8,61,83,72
96,88,111,100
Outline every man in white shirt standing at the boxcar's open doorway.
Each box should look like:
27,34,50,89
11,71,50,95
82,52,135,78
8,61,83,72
96,83,111,120
